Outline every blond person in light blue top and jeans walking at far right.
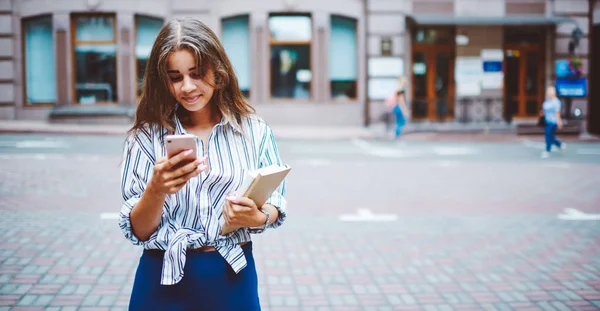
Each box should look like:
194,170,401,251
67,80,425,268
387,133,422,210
540,86,567,159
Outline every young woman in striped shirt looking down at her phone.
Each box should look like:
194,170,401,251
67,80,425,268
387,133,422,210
119,19,286,311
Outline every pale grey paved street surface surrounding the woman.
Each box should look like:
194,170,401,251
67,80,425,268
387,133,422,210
0,134,600,311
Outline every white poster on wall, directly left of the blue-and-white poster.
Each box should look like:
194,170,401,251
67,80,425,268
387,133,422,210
454,56,483,96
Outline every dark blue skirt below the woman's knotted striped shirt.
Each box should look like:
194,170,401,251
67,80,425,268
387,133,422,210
129,242,260,311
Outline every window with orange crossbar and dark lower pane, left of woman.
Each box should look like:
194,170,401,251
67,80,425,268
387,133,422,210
72,15,117,104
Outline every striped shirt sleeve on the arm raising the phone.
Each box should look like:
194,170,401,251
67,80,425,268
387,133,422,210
119,135,154,245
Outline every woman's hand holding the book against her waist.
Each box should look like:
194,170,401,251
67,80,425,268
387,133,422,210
223,196,266,228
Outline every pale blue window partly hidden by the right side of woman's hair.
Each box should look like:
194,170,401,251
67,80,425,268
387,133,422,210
222,16,251,98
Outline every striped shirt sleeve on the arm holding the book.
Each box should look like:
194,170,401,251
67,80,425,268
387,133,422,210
259,124,287,228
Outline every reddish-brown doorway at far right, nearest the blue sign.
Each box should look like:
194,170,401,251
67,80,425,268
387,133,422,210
504,28,545,122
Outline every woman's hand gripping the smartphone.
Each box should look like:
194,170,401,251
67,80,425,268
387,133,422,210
148,149,206,195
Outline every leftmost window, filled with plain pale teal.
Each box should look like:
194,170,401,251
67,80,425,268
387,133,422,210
23,16,56,104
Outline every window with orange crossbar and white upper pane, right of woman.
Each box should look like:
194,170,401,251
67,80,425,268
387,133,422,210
269,15,312,98
